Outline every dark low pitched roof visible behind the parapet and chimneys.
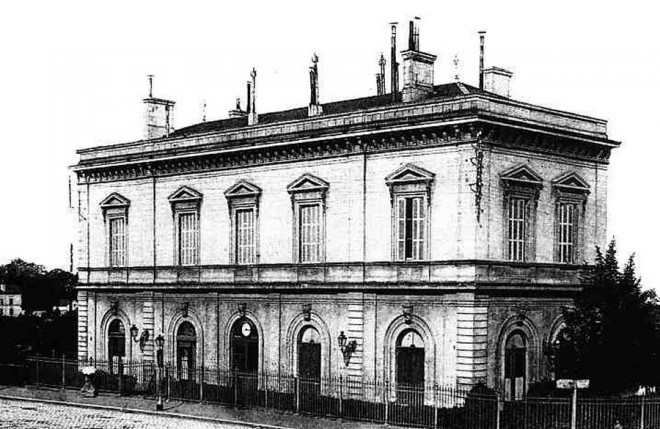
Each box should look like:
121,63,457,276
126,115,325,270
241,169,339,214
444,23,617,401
170,82,494,137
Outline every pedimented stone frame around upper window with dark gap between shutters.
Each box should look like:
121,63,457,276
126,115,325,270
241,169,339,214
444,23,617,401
385,164,435,262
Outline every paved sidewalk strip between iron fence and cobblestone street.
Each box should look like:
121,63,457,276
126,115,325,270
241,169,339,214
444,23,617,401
0,386,394,429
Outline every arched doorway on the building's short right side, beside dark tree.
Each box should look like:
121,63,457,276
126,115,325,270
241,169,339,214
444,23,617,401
504,331,527,401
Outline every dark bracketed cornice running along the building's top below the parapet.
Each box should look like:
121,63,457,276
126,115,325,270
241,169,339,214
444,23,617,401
76,118,617,184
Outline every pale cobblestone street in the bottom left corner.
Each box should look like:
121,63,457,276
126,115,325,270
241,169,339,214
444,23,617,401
0,399,254,429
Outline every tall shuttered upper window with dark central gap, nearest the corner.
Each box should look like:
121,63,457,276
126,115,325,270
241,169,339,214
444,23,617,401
396,197,426,261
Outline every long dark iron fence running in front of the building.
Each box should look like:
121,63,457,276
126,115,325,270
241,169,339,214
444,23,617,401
5,357,660,429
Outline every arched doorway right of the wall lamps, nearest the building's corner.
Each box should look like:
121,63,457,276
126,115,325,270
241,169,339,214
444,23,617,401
396,329,425,404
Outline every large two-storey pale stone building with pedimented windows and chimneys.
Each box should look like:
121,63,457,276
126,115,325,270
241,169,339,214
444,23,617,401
74,22,619,398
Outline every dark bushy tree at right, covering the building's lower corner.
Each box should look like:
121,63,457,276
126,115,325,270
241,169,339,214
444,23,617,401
557,240,658,392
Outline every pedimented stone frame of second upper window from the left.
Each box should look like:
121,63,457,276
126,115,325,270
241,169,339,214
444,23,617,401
168,186,202,267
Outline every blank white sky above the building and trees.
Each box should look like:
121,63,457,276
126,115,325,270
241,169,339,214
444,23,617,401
0,0,660,290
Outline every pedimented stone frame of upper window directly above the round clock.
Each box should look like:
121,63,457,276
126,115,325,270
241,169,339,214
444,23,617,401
225,180,262,265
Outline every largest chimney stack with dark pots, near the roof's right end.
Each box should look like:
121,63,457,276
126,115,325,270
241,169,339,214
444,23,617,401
401,18,437,103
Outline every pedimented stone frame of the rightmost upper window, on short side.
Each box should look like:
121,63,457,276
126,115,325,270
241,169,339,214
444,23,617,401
552,172,590,265
